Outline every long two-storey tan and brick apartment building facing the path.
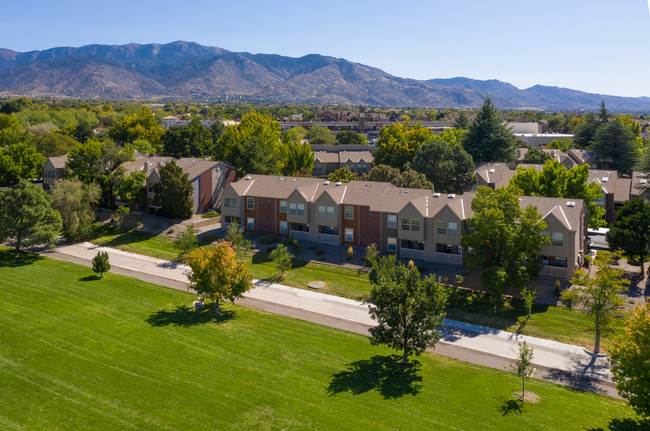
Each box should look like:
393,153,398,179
221,175,587,279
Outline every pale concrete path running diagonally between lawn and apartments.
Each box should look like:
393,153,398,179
39,243,618,397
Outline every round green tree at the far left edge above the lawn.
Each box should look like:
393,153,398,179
0,180,61,257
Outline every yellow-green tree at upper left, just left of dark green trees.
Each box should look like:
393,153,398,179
108,106,163,151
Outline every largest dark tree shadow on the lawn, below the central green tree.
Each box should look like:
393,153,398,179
327,355,422,399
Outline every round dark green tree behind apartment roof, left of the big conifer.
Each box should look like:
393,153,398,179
412,139,476,193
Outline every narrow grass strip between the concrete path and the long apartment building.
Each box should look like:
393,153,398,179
88,225,625,350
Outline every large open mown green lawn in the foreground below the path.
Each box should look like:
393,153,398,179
0,251,640,430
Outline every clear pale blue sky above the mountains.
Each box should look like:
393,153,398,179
0,0,650,96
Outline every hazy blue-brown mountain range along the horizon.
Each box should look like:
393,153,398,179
0,41,650,112
